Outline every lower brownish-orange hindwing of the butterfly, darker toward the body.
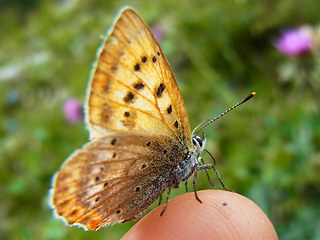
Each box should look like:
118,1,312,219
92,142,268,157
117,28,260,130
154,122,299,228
52,133,186,230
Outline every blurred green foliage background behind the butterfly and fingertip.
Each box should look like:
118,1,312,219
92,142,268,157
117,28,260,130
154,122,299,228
0,0,320,240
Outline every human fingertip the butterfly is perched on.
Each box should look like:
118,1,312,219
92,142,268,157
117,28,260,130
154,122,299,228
122,190,278,240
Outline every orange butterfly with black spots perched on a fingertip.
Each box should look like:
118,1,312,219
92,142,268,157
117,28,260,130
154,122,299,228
52,8,255,230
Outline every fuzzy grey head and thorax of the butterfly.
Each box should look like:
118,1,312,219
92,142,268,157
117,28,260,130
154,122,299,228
176,136,206,182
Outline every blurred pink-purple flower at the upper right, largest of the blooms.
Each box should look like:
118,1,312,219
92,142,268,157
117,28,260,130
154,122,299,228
273,26,312,56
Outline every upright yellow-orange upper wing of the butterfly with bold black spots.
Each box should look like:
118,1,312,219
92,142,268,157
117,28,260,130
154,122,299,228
87,8,192,147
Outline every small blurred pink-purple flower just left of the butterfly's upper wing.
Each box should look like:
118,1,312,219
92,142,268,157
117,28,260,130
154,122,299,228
63,98,83,123
